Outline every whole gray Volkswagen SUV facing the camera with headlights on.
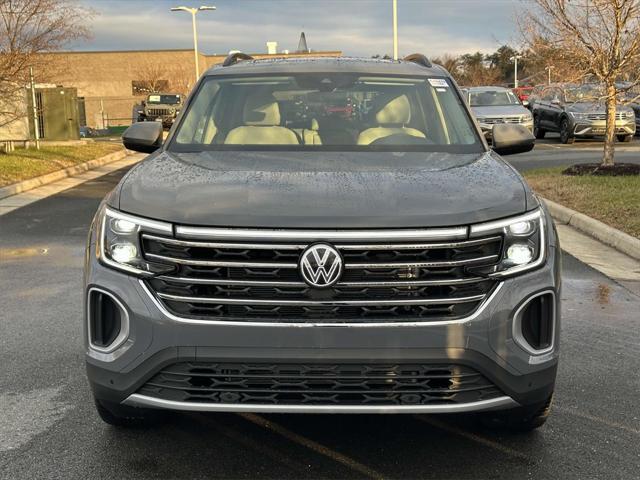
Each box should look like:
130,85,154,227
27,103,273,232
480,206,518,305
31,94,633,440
84,54,560,430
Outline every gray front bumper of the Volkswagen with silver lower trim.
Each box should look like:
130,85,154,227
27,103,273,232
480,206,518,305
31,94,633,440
84,228,560,413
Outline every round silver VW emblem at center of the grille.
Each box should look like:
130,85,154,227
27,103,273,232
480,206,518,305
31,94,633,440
299,243,344,288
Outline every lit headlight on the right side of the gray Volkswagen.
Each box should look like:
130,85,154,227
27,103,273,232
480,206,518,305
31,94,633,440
470,209,546,277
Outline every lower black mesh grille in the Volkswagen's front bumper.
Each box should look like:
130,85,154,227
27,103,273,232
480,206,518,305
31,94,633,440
138,362,503,405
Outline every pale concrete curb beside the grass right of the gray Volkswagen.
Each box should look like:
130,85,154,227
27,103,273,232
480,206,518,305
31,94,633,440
542,198,640,260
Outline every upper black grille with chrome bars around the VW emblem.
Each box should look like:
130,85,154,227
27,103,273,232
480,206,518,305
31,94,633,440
142,229,502,322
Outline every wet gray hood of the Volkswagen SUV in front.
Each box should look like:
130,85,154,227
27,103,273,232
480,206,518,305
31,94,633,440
114,151,535,229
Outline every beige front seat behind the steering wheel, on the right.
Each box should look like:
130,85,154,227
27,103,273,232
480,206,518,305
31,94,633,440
358,94,426,145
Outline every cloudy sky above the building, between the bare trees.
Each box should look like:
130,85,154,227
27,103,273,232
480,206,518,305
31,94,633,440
72,0,519,56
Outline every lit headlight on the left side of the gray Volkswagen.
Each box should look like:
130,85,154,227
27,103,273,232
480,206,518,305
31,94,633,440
96,207,173,276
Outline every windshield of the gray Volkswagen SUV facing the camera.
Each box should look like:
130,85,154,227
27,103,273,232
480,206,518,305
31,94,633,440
169,73,483,152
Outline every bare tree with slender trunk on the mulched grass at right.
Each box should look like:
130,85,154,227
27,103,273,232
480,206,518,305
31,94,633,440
521,0,640,166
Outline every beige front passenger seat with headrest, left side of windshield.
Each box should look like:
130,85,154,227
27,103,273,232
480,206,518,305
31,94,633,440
224,93,300,145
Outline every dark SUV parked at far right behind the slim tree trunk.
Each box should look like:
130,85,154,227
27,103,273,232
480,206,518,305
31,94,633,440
531,84,636,143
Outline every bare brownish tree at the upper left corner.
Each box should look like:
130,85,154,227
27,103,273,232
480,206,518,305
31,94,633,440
0,0,91,126
